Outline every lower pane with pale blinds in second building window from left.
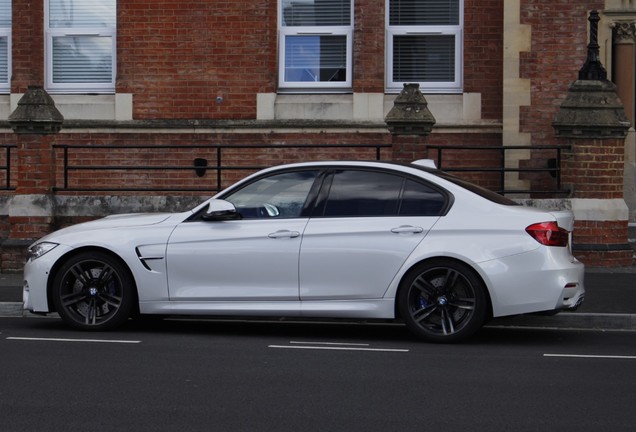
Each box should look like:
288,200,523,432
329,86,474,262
53,36,113,83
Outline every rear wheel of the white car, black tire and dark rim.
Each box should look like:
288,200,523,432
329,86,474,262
397,260,488,342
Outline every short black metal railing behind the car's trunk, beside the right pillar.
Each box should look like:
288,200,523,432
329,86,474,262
427,145,571,195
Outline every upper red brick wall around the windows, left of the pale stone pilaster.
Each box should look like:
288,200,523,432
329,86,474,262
12,0,503,120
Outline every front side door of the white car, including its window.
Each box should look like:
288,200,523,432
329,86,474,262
167,170,318,301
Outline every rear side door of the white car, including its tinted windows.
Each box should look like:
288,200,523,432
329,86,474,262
300,169,448,301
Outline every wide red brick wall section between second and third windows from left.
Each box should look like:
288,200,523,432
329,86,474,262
117,0,277,119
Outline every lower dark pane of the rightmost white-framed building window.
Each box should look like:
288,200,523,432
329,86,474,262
393,35,455,82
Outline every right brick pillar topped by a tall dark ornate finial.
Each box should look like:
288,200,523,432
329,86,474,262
552,11,633,266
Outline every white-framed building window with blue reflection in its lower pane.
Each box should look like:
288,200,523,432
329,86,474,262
278,0,353,90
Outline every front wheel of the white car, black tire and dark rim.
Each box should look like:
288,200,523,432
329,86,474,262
52,252,136,330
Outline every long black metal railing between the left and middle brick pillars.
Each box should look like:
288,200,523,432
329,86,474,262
53,144,391,192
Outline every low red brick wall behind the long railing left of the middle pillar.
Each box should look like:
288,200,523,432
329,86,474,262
55,132,391,195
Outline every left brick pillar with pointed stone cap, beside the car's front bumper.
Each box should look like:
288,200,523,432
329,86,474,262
1,86,64,269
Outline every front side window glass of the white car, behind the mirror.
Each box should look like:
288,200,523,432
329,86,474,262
225,171,318,219
